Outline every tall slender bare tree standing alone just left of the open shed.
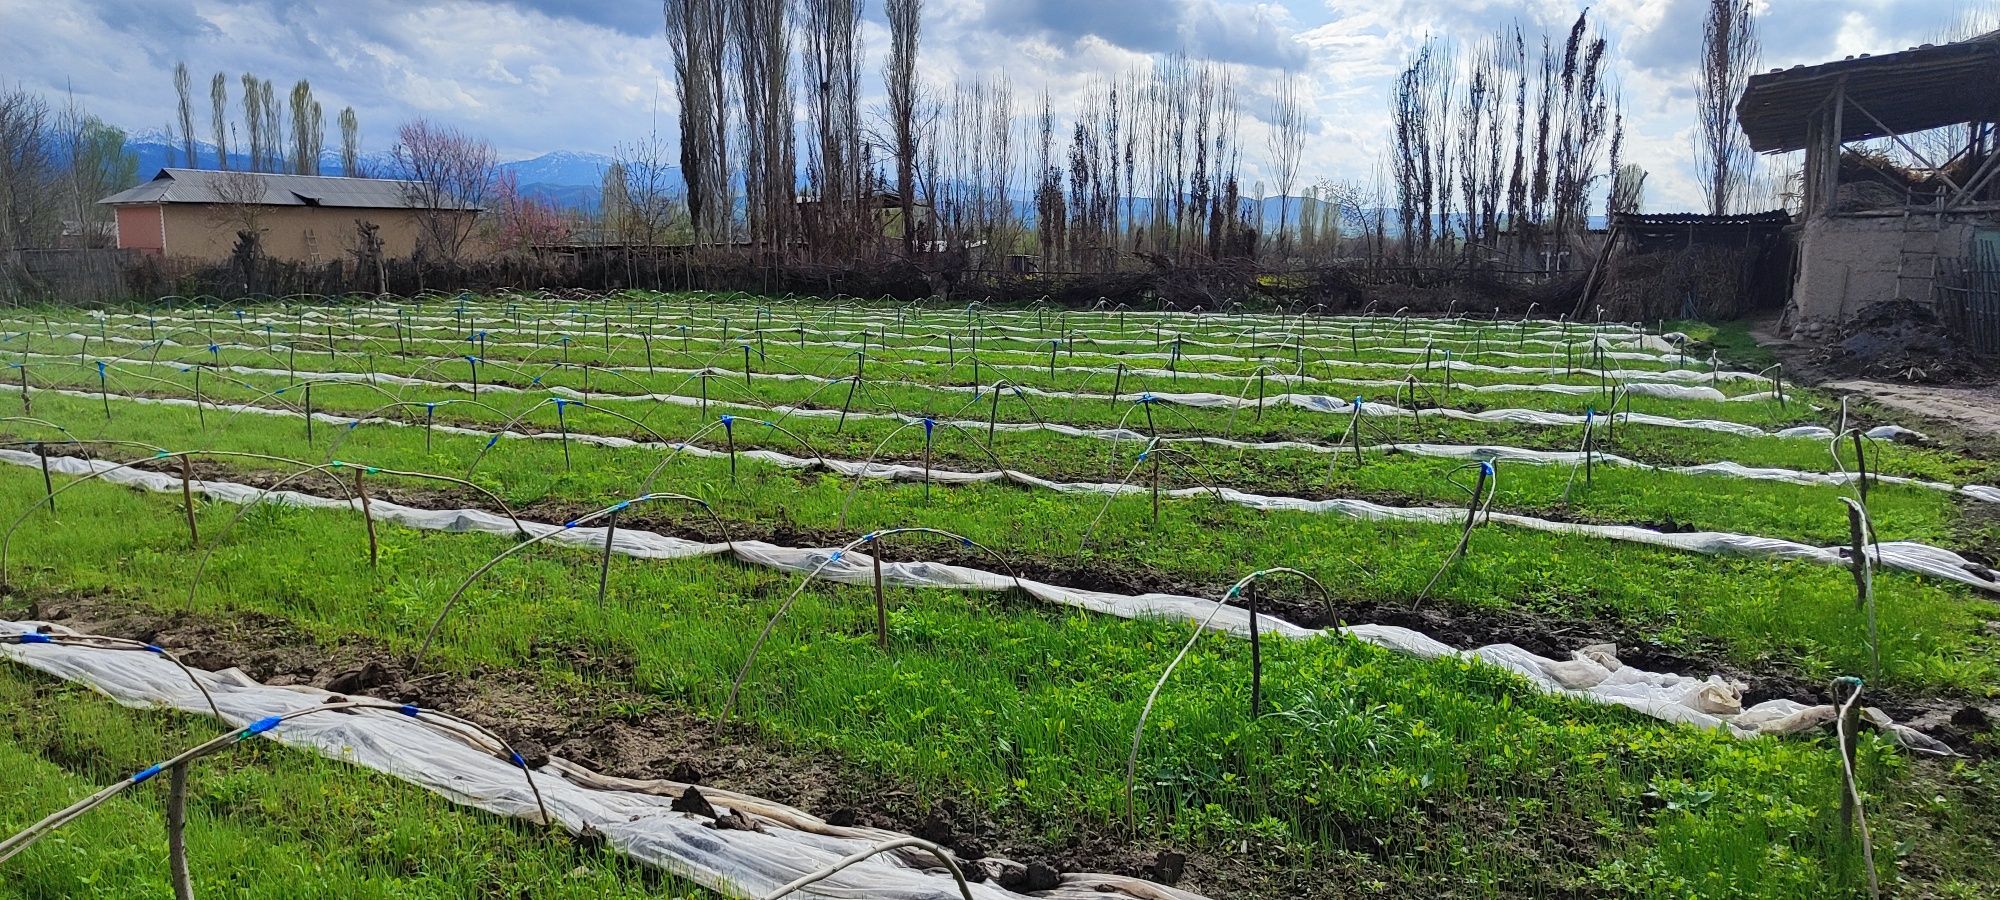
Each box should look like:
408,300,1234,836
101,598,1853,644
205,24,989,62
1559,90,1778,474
1694,0,1758,216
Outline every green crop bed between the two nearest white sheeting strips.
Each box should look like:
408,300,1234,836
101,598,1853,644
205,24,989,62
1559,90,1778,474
0,468,1984,896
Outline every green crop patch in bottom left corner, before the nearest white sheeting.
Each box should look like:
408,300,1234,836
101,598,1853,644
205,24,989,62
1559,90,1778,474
0,664,712,900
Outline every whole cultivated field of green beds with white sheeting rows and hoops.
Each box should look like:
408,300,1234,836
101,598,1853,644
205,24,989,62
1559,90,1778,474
0,292,2000,898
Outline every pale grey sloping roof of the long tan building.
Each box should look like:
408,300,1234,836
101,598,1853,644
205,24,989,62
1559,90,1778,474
98,168,482,210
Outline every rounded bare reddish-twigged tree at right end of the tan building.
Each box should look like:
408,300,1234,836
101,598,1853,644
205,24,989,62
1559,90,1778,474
392,118,498,266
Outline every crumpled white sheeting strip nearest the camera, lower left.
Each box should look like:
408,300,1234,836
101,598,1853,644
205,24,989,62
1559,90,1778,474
0,622,1202,900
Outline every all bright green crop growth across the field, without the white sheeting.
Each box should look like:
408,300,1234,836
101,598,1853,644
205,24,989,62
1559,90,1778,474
0,300,2000,900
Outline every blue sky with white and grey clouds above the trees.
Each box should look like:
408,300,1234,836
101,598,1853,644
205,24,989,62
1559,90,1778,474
0,0,2000,210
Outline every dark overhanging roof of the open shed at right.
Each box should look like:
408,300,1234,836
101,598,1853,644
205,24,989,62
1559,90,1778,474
1736,32,2000,154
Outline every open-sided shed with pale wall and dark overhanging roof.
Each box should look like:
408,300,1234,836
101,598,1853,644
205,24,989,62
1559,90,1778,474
1736,32,2000,344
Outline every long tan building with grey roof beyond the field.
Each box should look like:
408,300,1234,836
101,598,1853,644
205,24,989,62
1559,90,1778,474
98,168,480,264
